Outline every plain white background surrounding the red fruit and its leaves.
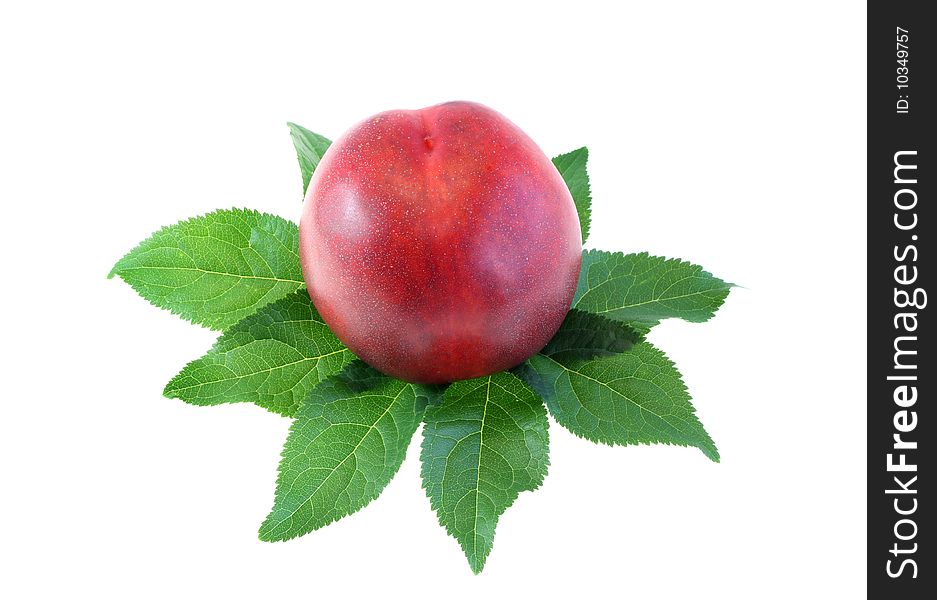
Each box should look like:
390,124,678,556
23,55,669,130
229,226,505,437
0,0,866,599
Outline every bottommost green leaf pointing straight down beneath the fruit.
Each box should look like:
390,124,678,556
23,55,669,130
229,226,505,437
421,372,549,573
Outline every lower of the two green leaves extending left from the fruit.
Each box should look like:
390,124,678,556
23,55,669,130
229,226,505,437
163,289,354,416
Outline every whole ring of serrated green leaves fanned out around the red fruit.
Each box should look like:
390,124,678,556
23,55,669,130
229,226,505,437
110,123,731,573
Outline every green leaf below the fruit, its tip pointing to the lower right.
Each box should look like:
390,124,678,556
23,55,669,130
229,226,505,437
517,342,719,462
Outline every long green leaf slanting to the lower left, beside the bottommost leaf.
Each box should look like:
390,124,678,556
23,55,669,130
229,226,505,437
260,361,426,542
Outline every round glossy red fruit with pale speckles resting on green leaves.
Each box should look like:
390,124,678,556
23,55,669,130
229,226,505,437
299,102,582,383
